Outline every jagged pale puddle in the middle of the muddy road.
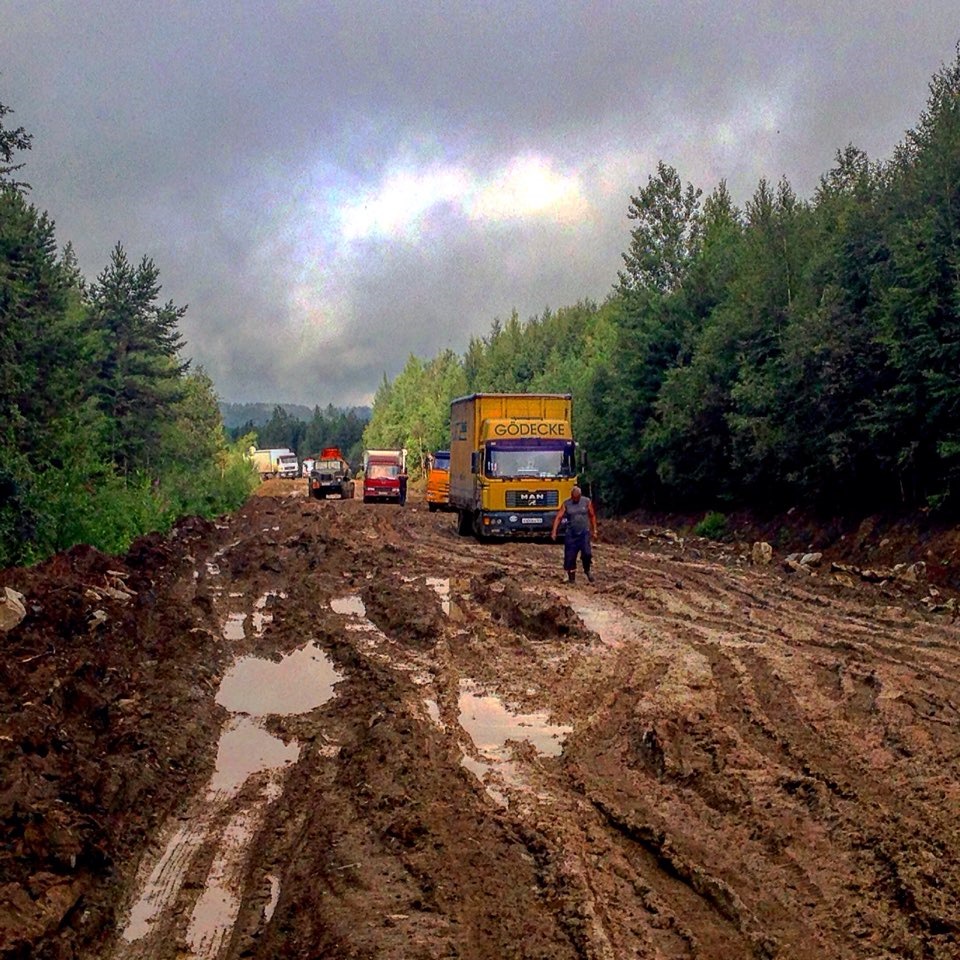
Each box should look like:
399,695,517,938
458,680,573,806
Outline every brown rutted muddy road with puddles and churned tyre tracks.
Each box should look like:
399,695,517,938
0,481,960,960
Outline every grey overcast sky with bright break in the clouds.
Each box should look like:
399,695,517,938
0,0,960,406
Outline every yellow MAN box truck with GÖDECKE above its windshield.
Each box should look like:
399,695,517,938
450,393,577,538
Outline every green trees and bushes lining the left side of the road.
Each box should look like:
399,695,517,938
0,104,256,566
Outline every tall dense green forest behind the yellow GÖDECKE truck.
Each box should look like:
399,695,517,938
366,48,960,513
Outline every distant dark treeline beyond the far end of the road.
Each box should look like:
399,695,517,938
227,404,370,464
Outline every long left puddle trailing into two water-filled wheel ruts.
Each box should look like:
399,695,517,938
117,636,340,960
